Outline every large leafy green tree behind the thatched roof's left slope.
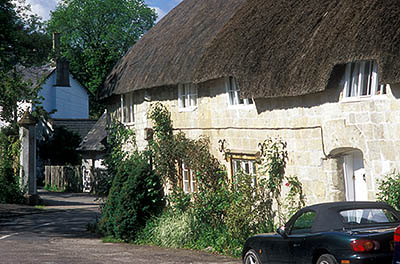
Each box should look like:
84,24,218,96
47,0,156,116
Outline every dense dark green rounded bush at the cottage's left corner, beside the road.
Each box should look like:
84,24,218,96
99,153,163,241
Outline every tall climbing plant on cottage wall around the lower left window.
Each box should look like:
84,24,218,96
148,103,225,192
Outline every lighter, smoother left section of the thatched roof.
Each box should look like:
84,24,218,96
98,0,245,98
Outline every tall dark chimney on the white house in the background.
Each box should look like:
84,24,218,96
53,32,70,87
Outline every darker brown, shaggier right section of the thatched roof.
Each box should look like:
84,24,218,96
195,0,400,97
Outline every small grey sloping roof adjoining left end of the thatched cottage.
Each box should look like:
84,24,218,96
77,113,107,151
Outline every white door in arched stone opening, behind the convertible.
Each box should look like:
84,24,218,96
343,150,368,201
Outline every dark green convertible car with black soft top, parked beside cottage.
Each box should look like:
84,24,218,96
242,202,400,264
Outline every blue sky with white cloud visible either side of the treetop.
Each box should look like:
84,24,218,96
22,0,182,20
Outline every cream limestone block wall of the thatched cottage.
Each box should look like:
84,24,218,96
109,79,400,204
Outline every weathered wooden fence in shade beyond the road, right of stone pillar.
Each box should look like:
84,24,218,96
45,166,83,192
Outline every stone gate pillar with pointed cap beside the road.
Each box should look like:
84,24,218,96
18,111,39,204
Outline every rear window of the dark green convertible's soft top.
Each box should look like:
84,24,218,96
340,208,399,225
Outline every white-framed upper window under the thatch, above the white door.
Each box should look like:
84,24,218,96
344,61,386,97
